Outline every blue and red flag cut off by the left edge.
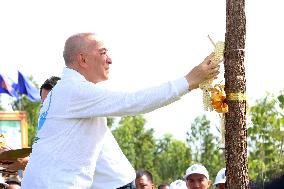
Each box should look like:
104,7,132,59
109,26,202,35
0,74,18,98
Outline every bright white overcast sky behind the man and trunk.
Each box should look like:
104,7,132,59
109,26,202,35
0,0,284,140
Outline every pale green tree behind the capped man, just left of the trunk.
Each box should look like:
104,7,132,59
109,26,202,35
187,115,225,182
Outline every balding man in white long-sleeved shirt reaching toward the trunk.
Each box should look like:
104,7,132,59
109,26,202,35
22,33,222,189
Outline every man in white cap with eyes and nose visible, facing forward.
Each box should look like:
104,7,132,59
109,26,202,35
184,164,211,189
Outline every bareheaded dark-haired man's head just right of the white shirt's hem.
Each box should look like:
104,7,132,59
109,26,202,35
135,170,154,189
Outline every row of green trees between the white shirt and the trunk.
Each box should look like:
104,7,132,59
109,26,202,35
113,115,225,184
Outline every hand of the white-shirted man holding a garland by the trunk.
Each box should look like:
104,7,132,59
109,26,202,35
185,53,223,90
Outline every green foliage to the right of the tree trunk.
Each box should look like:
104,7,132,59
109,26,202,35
248,93,284,182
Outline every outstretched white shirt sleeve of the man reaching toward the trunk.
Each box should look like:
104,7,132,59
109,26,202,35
51,77,189,118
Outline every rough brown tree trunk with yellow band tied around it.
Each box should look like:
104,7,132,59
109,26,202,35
224,0,249,189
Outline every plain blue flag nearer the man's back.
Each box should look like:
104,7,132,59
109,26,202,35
17,71,40,102
